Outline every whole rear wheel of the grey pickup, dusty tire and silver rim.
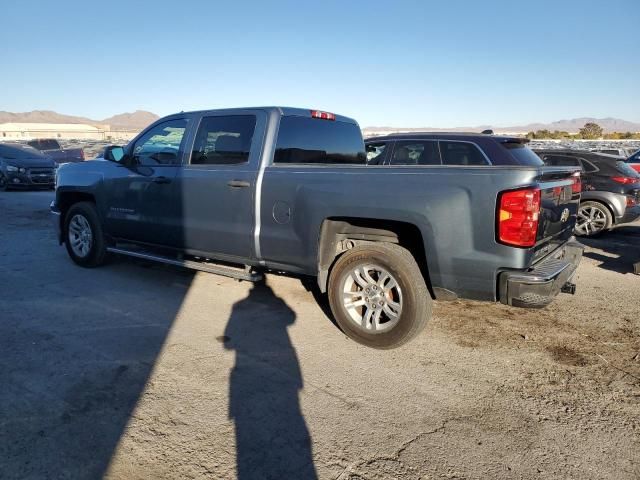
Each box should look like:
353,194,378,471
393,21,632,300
328,243,432,349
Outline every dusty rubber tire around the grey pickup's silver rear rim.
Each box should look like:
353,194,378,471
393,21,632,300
328,243,432,349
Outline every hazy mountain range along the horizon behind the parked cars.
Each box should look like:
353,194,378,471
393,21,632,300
0,110,640,136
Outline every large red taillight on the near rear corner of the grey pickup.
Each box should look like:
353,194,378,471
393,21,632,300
496,188,540,247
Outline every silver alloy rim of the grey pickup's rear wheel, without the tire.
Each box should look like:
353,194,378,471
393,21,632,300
342,265,402,333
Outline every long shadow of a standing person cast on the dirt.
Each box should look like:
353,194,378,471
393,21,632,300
224,282,317,480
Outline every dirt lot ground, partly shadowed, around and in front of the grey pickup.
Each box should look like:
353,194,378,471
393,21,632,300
0,192,640,480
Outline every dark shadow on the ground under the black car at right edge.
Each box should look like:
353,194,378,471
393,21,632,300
580,224,640,274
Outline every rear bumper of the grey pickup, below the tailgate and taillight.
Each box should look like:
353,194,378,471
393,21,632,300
498,238,584,308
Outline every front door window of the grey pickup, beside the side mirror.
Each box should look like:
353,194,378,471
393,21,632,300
132,118,187,166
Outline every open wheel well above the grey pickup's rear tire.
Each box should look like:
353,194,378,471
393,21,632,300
318,217,436,299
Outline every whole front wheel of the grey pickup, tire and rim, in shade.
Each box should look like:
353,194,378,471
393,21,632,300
64,202,107,267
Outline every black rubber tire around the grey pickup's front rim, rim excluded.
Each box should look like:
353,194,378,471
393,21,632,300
63,202,107,268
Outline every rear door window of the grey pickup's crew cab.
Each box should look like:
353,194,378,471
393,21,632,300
191,115,256,165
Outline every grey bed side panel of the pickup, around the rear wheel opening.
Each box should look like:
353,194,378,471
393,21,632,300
260,165,537,299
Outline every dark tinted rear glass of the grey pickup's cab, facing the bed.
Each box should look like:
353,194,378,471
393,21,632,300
273,116,367,165
